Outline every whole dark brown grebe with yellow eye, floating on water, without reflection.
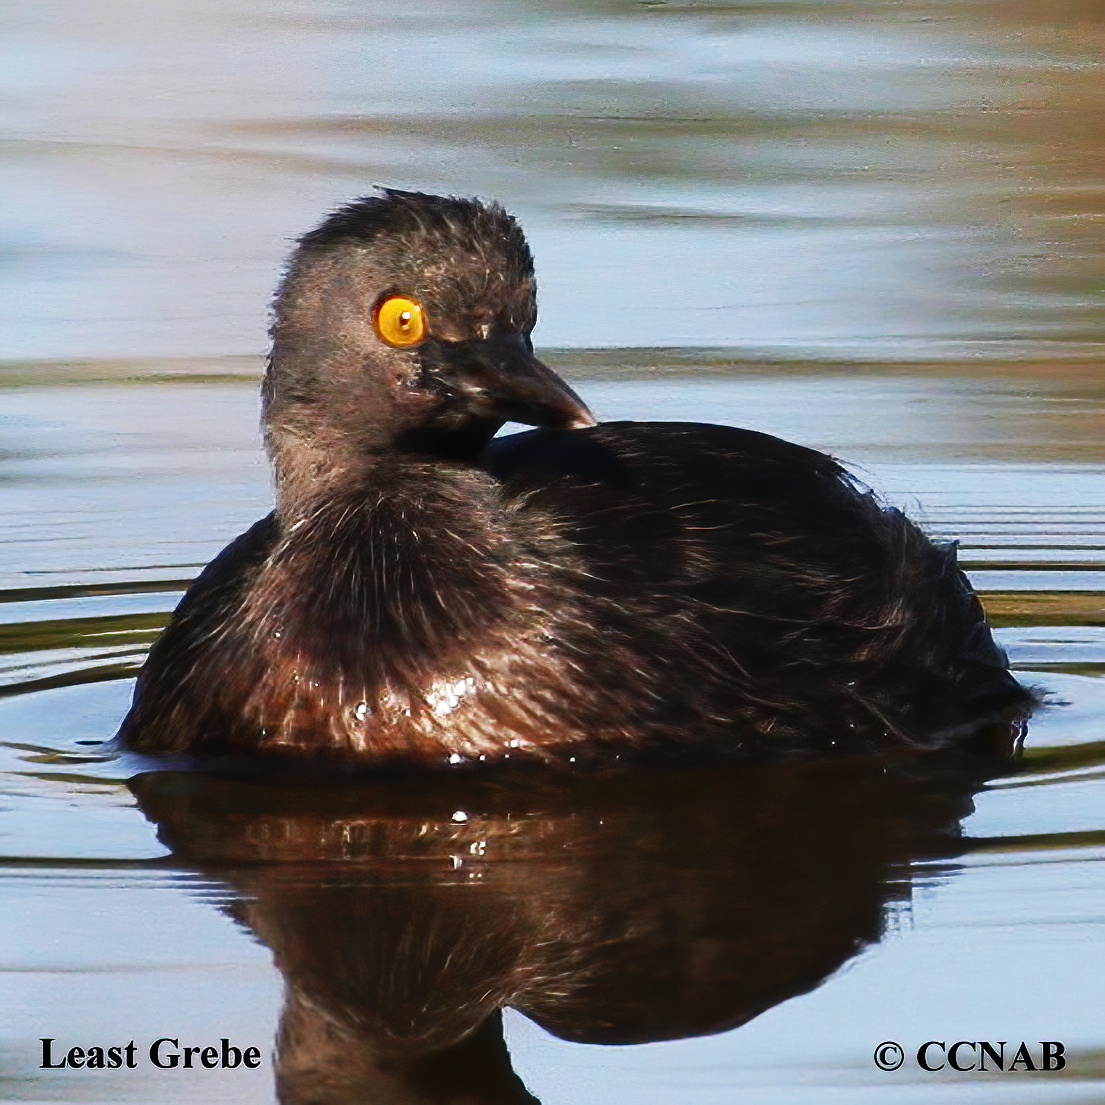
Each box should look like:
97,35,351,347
120,190,1031,766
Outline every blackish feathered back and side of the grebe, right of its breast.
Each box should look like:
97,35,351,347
483,422,1031,753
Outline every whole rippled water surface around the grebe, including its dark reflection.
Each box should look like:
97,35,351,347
0,0,1105,1105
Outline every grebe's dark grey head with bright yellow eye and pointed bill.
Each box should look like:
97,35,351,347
263,189,593,506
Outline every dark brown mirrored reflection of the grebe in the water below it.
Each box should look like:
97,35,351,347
130,724,1012,1105
